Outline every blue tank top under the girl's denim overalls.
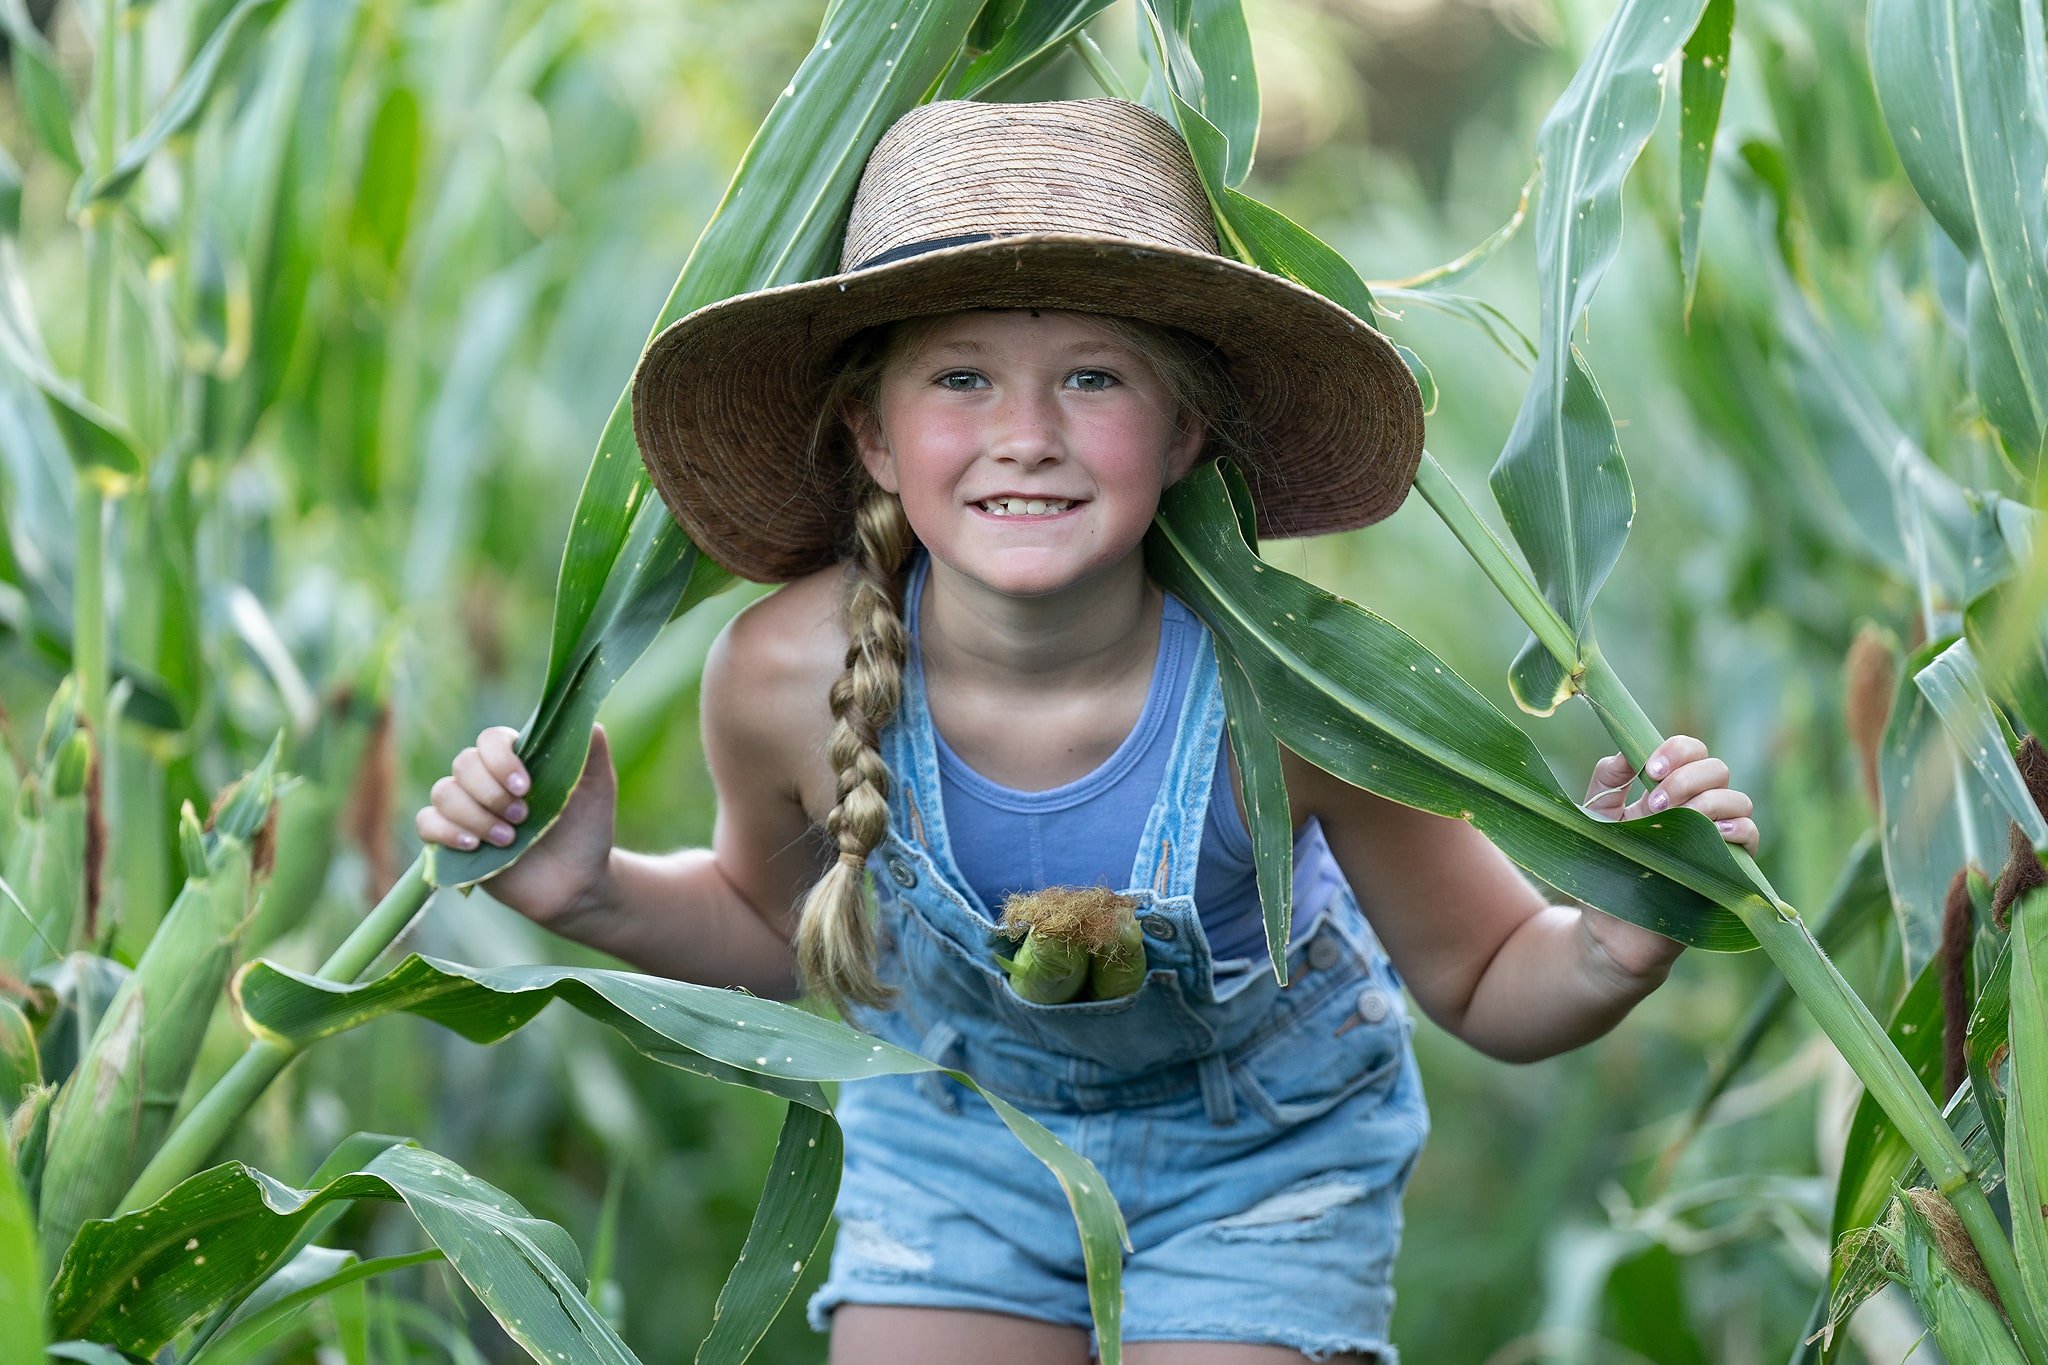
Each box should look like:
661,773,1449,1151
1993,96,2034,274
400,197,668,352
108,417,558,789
903,553,1341,962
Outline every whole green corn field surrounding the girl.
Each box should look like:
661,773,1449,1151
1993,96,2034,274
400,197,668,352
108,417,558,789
0,0,2048,1365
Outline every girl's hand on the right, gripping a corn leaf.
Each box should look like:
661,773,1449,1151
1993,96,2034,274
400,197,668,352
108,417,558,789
1579,735,1759,980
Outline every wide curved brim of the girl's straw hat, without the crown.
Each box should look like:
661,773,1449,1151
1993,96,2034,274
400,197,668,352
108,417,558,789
633,233,1423,583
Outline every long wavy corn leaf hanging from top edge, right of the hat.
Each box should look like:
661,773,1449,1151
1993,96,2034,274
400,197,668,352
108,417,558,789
1491,0,1706,714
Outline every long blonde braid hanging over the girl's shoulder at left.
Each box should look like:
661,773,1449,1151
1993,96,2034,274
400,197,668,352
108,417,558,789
797,489,913,1011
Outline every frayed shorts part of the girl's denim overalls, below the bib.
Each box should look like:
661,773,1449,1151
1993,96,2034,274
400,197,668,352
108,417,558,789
809,879,1430,1365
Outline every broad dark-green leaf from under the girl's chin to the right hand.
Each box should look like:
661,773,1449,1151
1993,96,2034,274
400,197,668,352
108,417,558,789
1147,463,1757,950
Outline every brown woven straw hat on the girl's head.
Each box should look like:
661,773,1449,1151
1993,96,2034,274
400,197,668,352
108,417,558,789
633,100,1421,583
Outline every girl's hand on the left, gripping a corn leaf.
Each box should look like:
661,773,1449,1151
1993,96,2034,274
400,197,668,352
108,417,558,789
414,724,618,925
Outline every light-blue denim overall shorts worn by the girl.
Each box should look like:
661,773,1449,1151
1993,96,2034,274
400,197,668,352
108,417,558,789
809,573,1430,1365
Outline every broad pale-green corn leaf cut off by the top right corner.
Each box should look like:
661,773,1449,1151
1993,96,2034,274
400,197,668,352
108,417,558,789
1870,0,2048,473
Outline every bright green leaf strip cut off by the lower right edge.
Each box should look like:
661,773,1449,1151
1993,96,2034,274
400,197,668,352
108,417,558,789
2005,892,2048,1304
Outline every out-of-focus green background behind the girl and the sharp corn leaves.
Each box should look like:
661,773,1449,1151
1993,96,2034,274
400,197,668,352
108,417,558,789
0,0,1997,1365
